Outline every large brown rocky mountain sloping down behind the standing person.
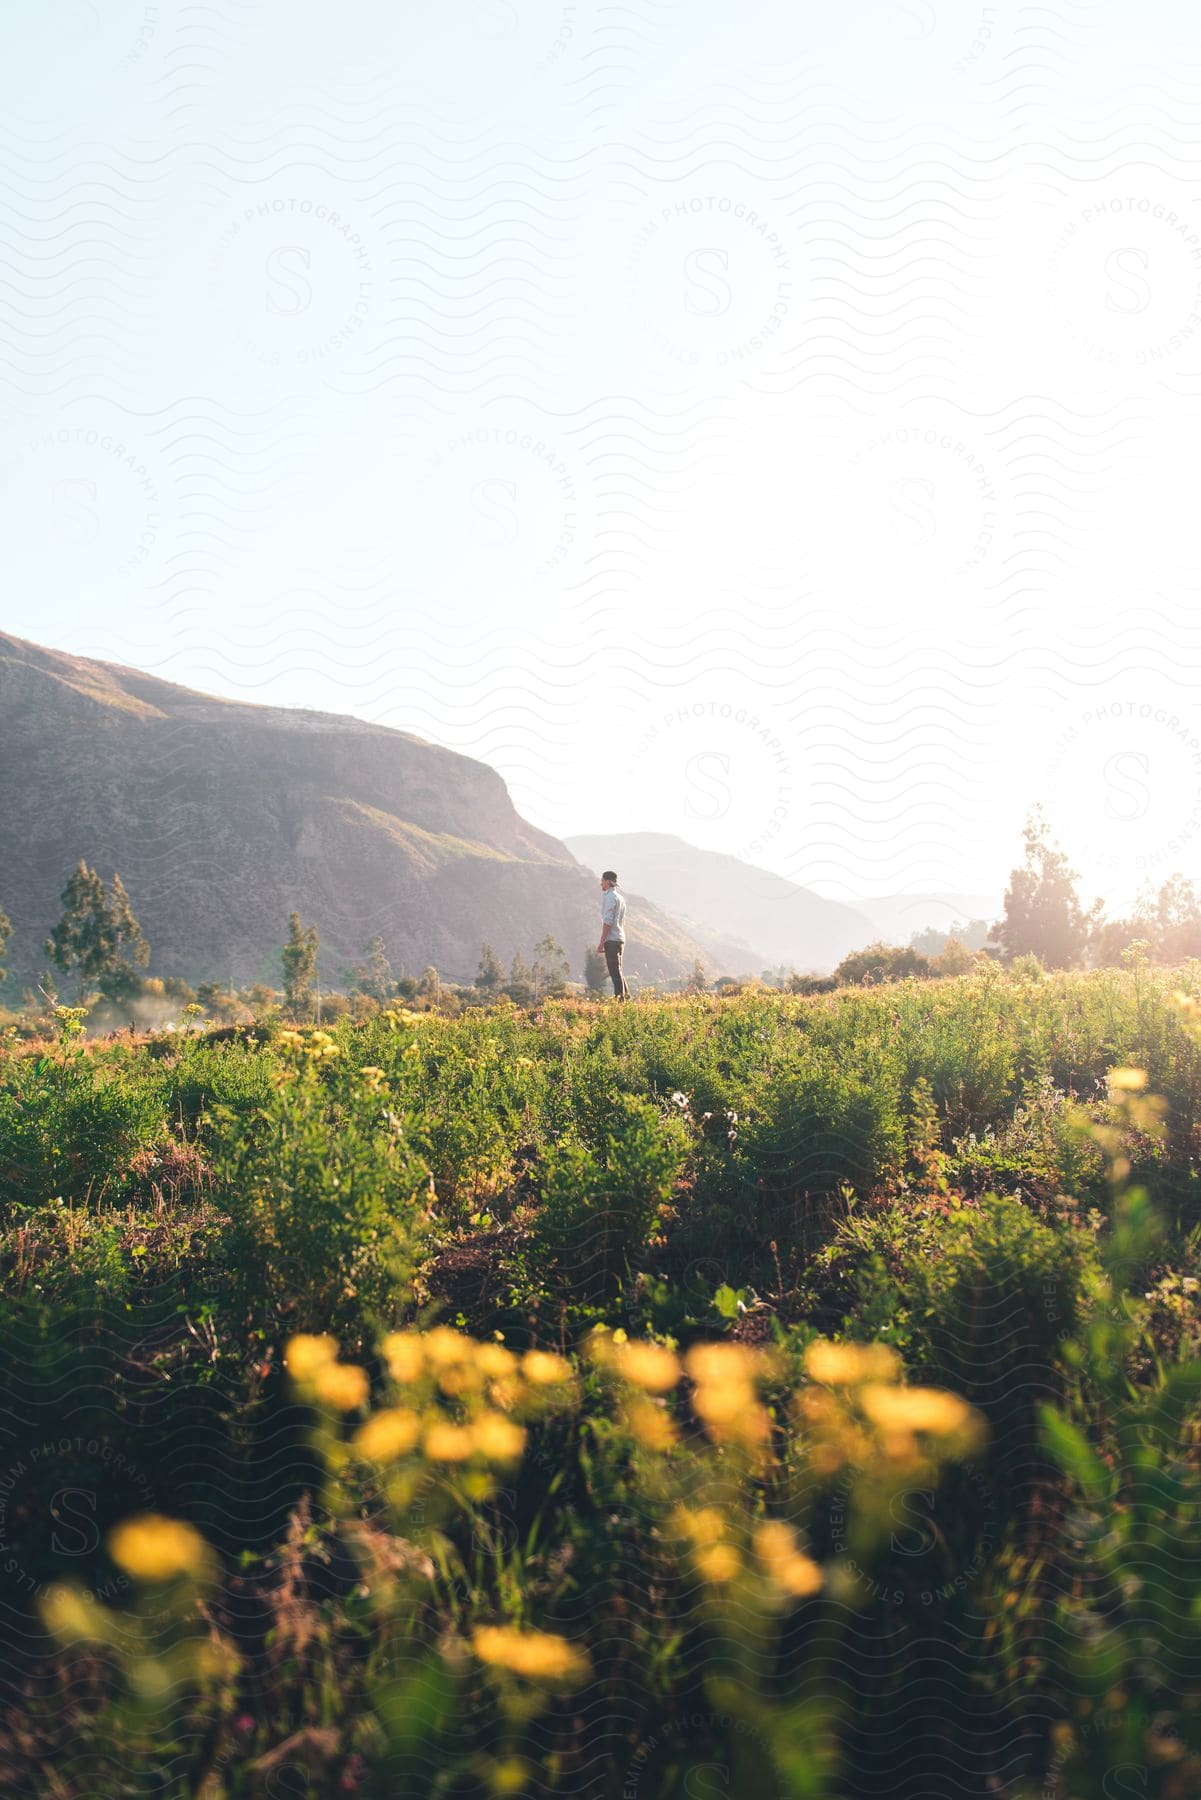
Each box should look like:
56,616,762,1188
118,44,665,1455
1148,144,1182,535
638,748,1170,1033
0,634,751,997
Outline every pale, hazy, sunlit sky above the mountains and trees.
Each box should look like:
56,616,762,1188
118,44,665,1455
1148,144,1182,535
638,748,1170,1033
0,0,1201,902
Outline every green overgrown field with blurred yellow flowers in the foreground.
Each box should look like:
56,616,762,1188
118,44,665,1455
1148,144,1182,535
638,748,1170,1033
0,961,1201,1800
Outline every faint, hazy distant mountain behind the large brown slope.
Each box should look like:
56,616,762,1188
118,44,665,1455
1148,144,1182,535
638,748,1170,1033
567,832,875,976
